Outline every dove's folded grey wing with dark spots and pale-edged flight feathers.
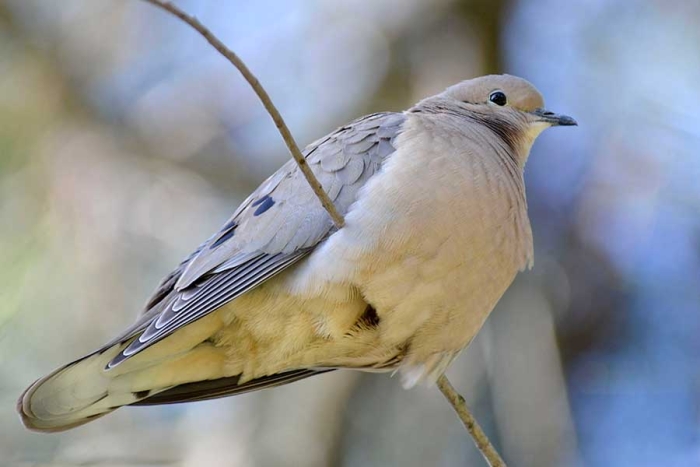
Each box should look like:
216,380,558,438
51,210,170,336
108,113,405,368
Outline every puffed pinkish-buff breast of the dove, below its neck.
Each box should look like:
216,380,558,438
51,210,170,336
284,107,532,380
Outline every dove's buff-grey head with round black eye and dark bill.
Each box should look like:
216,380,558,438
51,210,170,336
413,75,576,164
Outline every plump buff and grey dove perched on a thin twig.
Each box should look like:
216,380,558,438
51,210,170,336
17,75,577,432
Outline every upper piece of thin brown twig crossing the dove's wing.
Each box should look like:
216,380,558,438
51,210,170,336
143,0,345,229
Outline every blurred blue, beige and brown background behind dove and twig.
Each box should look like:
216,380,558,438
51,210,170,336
0,0,700,467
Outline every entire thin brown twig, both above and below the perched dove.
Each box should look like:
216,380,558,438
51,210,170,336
143,0,506,467
